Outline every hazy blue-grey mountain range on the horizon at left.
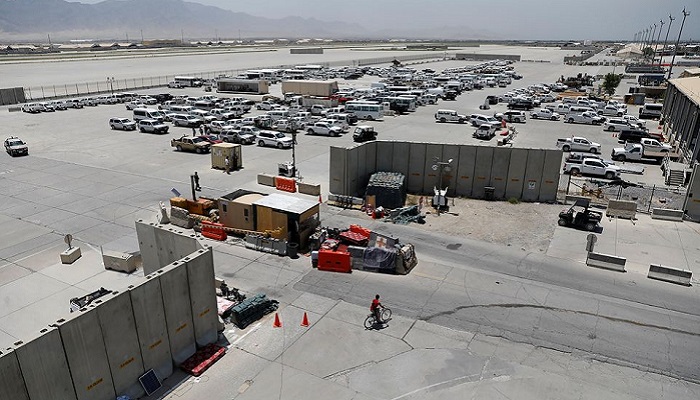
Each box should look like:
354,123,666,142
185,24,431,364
0,0,492,41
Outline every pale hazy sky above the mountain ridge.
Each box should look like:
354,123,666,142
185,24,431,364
72,0,700,42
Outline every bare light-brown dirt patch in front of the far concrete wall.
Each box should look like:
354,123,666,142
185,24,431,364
410,199,566,253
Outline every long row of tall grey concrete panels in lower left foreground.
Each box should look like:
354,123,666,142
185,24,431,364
0,228,218,400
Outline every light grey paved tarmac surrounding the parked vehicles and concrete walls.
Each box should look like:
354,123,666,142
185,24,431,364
0,48,700,399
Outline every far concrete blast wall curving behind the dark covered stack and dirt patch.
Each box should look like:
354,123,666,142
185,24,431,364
329,141,561,202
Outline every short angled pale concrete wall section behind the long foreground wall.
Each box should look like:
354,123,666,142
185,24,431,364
136,220,202,275
